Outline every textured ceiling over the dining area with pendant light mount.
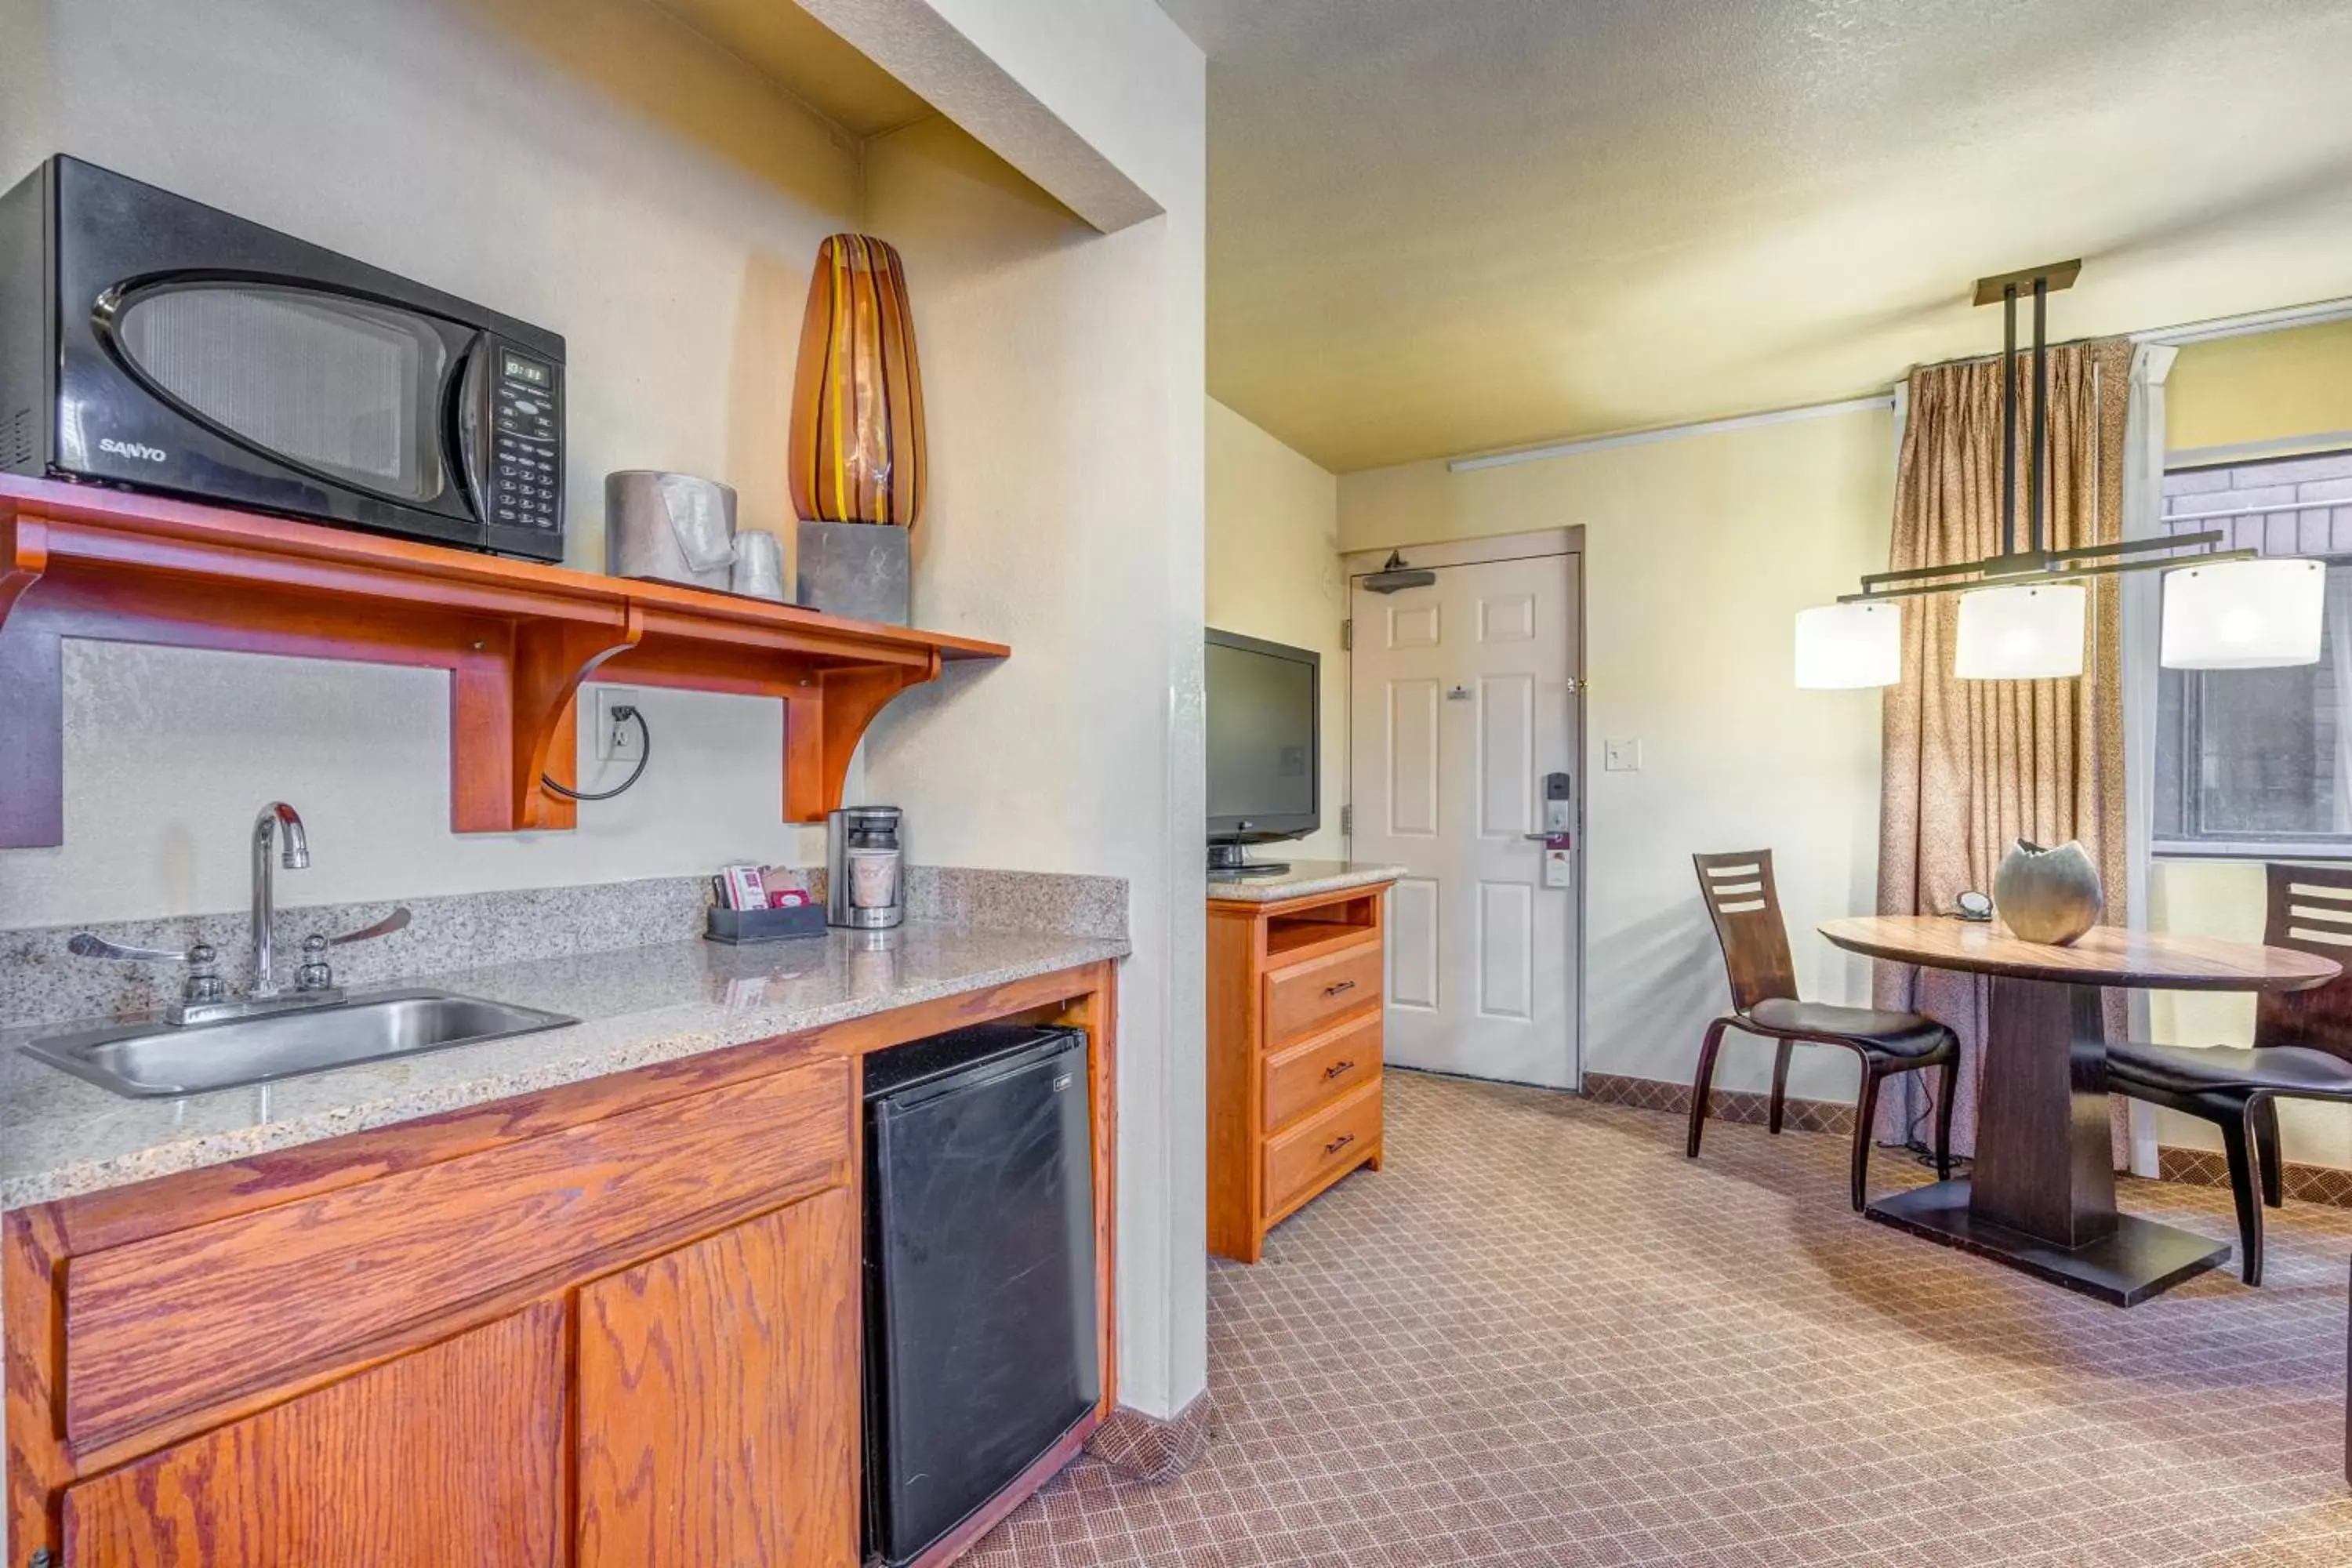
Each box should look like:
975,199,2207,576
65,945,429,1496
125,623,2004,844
1162,0,2352,470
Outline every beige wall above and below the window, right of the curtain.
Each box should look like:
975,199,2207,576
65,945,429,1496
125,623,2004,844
2147,322,2352,1166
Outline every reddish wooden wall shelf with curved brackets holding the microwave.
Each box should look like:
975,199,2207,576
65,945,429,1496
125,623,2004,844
0,475,1011,848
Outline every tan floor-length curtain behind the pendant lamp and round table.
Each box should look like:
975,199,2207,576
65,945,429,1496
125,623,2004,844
1877,339,2131,1154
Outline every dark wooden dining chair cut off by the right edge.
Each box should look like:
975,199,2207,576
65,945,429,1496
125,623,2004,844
2107,865,2352,1286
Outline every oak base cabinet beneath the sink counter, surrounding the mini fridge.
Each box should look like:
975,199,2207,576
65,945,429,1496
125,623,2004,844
0,961,1117,1568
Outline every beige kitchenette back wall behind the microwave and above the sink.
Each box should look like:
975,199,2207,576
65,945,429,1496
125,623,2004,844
0,0,875,926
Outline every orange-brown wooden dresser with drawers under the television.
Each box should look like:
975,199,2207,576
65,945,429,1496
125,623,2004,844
1209,877,1390,1262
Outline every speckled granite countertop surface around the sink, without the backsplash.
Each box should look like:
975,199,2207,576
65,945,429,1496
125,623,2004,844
0,921,1129,1208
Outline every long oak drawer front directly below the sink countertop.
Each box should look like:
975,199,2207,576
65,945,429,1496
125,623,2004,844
64,1060,854,1446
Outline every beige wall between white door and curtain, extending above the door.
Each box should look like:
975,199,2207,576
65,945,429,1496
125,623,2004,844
1338,412,1893,1098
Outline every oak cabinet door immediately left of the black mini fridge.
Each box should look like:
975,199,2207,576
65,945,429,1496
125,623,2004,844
576,1187,858,1568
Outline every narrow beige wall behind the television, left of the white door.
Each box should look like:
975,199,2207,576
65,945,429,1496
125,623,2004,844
1207,397,1348,860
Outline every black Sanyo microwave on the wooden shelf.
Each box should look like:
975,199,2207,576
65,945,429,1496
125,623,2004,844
0,155,564,562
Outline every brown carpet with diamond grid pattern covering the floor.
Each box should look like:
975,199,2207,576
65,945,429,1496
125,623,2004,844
964,1074,2352,1568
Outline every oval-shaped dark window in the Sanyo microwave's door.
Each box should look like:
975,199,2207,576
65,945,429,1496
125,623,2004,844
115,285,449,501
